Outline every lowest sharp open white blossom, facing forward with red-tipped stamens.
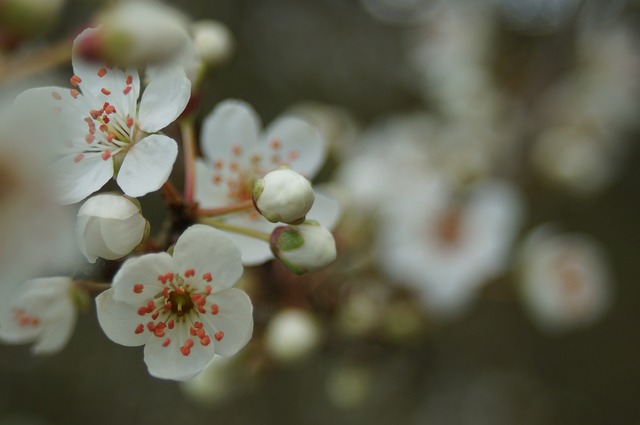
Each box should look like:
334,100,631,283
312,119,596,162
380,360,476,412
96,225,253,380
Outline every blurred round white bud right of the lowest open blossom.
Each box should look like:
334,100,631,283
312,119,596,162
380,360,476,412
265,308,322,362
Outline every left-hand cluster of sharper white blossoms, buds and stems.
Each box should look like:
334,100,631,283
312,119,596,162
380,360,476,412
0,2,339,380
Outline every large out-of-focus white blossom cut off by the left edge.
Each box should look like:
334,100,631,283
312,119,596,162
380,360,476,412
0,109,79,286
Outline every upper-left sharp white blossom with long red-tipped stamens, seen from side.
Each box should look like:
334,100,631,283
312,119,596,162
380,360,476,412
17,29,191,204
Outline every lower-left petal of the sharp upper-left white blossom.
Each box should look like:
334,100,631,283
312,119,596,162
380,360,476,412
53,153,113,205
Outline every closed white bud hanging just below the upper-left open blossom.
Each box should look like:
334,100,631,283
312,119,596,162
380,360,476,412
76,194,148,263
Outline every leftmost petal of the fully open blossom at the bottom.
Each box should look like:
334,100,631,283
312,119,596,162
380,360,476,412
96,288,149,347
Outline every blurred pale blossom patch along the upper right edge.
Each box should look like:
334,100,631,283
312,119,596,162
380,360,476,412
532,26,640,195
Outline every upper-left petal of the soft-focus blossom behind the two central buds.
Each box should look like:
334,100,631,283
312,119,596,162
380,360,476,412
200,100,261,162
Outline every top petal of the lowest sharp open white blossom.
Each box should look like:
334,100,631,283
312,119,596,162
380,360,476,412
173,224,242,293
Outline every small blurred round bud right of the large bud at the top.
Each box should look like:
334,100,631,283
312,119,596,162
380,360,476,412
191,19,234,65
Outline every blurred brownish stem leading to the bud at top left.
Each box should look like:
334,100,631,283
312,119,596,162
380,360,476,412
0,39,71,81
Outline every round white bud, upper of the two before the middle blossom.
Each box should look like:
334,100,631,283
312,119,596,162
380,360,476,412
253,168,315,224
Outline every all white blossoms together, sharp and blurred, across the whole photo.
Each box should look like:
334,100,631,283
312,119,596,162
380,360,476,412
0,0,640,405
